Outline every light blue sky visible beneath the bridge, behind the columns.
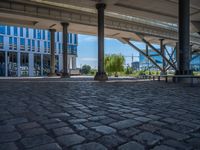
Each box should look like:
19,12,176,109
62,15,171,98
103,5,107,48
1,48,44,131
77,34,145,68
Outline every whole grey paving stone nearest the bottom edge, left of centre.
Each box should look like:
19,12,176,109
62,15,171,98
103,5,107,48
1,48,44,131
56,134,85,147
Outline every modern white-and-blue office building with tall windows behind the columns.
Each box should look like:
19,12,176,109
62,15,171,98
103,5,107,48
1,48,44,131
0,25,78,76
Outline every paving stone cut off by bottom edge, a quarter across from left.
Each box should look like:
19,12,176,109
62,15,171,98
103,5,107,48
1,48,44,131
30,143,62,150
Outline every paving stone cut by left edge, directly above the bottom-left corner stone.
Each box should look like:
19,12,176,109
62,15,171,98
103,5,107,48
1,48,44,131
0,132,21,143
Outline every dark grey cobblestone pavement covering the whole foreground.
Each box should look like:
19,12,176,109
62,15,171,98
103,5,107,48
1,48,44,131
0,79,200,150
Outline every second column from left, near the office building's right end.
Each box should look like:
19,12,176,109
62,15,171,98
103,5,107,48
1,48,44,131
62,23,70,78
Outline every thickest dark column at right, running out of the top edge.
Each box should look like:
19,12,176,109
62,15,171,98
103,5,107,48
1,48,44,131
176,0,192,75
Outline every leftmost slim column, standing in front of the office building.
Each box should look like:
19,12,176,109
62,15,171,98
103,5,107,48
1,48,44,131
49,29,56,76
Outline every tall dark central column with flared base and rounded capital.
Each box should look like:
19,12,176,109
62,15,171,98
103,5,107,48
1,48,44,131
94,3,108,81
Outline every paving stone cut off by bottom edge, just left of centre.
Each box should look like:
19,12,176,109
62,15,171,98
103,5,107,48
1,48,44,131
72,142,107,150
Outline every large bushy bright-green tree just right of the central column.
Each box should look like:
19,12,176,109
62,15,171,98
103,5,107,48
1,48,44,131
104,54,125,77
